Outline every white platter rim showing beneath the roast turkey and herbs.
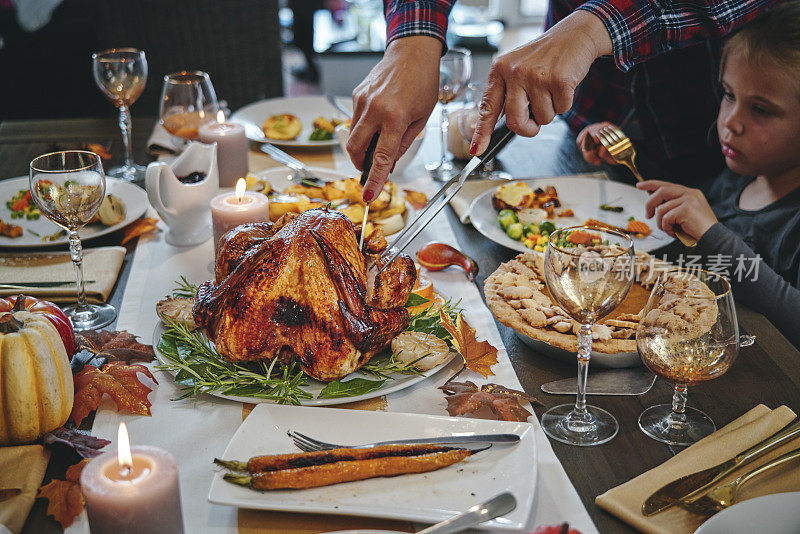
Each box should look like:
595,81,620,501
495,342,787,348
153,321,455,406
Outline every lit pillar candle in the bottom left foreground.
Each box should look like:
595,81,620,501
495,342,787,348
81,423,183,534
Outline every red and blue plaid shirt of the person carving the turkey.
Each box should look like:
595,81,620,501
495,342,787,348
384,0,783,179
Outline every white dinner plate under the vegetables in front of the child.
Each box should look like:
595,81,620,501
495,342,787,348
469,177,673,252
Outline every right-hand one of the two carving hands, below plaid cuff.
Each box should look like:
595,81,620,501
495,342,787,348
470,10,612,155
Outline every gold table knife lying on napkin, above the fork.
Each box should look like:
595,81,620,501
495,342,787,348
642,421,800,516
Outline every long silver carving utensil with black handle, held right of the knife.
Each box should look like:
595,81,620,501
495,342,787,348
373,119,514,274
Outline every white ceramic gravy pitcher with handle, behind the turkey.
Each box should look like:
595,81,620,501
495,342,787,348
145,143,219,246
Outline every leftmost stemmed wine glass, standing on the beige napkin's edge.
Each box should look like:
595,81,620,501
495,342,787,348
30,150,117,330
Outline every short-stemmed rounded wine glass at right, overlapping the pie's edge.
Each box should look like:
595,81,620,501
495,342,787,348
636,268,747,445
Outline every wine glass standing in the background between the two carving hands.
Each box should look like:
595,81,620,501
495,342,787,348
425,47,472,181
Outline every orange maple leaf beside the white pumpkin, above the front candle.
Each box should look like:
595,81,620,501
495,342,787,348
72,362,158,426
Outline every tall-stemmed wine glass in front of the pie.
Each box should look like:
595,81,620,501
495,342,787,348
542,226,634,446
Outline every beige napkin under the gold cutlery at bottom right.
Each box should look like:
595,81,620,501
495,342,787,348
595,404,800,534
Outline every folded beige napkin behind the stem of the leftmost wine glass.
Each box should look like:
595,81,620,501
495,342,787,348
0,247,125,303
